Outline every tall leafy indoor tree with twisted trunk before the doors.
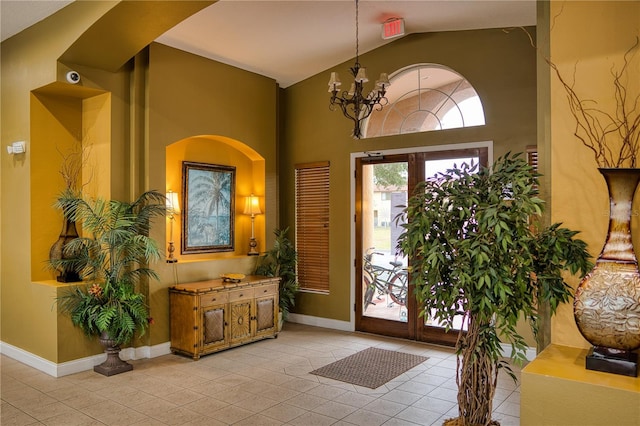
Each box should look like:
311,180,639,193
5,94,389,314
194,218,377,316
397,154,591,426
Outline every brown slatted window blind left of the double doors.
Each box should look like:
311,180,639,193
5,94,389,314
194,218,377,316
295,161,329,293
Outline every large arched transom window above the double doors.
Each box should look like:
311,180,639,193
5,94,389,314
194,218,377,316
364,64,485,138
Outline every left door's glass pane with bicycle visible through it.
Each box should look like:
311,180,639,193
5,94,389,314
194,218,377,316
361,162,408,322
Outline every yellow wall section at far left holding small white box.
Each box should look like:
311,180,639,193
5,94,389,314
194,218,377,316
0,2,120,362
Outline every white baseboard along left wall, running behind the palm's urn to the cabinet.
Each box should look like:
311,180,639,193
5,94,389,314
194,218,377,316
0,342,171,377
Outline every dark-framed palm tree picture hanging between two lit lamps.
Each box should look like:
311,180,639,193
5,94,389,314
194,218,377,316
181,161,236,254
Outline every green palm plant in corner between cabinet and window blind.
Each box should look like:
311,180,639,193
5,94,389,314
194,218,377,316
255,228,299,327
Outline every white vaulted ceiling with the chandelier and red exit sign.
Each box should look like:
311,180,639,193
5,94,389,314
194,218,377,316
0,0,536,87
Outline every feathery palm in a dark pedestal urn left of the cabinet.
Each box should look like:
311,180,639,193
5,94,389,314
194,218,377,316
50,191,166,376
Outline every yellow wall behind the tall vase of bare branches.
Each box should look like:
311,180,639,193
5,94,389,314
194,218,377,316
550,1,640,348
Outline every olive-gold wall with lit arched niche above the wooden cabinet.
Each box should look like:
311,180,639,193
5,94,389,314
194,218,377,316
148,43,278,344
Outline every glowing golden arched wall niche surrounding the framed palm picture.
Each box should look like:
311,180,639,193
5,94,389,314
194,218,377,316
166,135,271,262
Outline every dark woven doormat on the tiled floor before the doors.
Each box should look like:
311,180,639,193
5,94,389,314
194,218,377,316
310,348,428,389
